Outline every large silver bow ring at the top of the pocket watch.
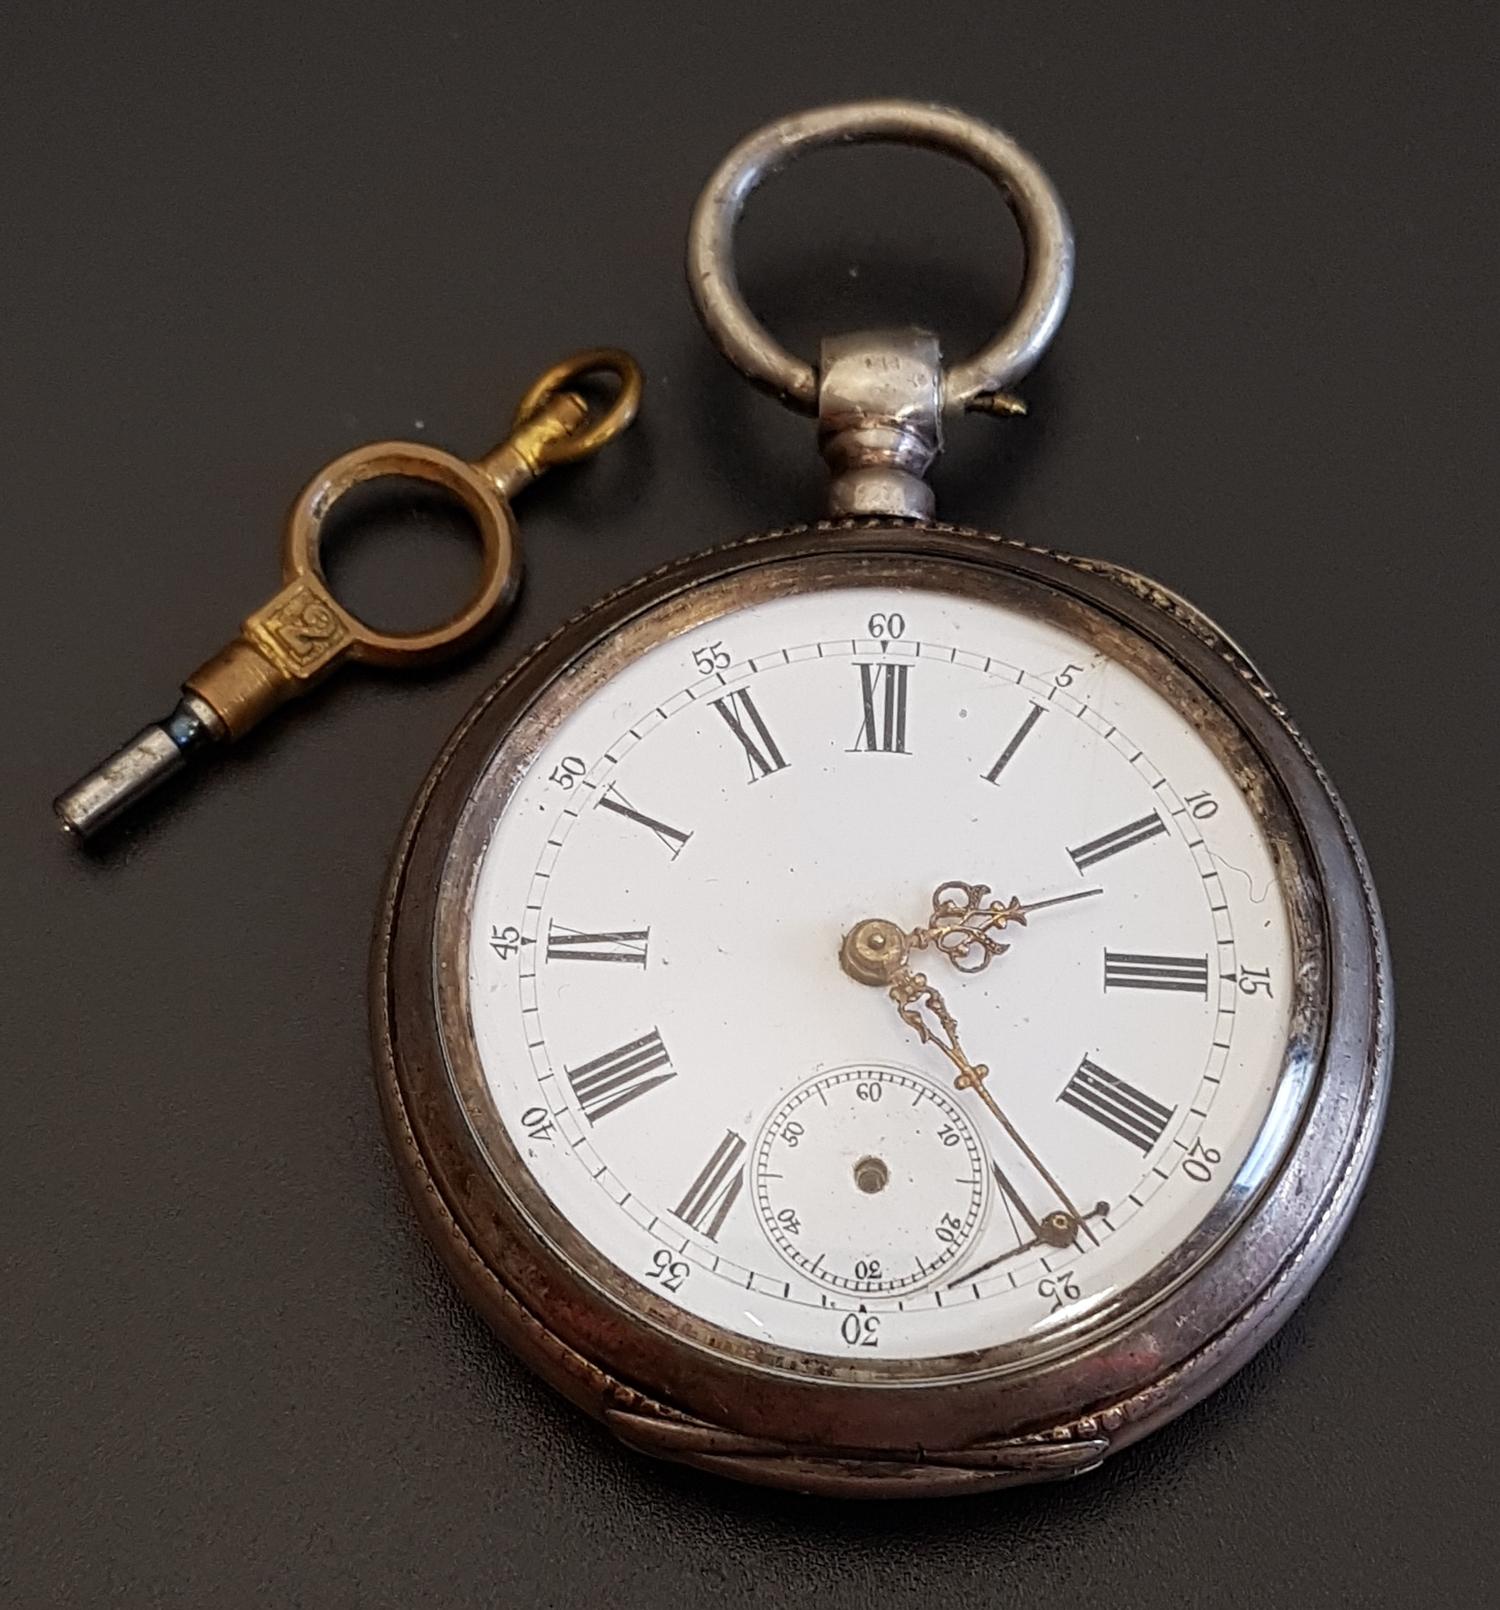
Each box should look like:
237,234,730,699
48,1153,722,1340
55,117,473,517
687,100,1073,414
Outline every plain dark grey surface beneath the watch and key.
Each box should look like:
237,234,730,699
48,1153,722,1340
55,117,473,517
0,0,1500,1610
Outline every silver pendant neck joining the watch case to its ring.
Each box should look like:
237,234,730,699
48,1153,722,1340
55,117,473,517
818,330,943,520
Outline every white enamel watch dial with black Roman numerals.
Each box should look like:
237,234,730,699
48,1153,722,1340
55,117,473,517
467,586,1296,1364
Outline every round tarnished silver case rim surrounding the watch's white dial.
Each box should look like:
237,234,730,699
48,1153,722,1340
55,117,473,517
373,522,1391,1497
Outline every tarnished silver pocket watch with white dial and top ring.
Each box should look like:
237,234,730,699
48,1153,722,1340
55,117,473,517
373,101,1391,1497
